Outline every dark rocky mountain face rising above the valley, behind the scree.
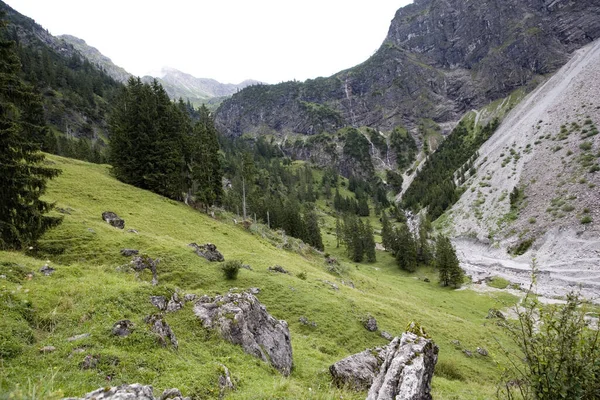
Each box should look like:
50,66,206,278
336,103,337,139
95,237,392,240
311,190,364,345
216,0,600,136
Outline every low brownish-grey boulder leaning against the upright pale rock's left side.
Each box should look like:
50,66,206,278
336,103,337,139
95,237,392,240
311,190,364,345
329,348,383,390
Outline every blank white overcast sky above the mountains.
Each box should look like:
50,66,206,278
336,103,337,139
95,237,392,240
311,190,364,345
5,0,412,83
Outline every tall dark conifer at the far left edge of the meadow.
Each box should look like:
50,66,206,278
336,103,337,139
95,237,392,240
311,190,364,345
0,13,61,249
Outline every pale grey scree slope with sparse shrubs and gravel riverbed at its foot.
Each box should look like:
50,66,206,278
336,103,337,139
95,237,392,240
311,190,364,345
446,41,600,296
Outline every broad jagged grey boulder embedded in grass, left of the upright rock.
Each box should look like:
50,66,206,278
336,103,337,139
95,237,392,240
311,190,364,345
194,292,292,376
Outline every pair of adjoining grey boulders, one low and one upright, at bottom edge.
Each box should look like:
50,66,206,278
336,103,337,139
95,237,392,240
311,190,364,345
329,332,438,400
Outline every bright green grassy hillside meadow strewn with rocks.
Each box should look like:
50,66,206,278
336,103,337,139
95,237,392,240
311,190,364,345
0,156,514,399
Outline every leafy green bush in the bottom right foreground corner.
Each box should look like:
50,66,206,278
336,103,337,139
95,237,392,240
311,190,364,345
500,293,600,400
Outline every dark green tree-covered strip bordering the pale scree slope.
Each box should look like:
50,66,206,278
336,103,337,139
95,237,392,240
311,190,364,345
402,119,499,221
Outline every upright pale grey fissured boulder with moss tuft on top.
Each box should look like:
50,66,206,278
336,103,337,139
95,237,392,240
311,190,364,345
367,332,439,400
